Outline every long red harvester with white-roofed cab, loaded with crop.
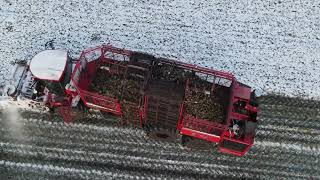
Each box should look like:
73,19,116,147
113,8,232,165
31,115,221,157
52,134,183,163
8,45,257,156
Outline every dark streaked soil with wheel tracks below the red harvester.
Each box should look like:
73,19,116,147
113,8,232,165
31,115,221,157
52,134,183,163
0,96,320,179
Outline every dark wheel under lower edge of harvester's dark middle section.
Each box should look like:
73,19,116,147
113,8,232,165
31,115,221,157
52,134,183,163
147,128,178,142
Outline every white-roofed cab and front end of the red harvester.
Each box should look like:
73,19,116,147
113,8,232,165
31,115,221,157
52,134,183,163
5,50,73,108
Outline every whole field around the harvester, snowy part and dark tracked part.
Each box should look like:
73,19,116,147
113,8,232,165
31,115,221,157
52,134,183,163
0,0,320,179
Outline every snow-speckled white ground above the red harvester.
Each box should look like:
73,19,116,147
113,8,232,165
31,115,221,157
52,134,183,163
0,0,320,98
